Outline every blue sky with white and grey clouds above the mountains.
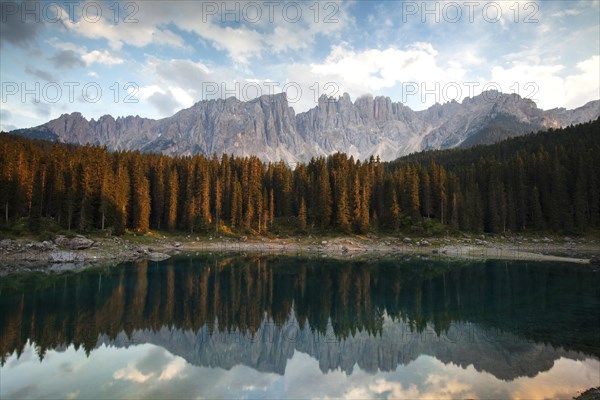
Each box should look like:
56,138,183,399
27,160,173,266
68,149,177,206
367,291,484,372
0,0,600,131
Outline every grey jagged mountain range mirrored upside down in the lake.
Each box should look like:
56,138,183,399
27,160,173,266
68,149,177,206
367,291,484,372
98,318,586,380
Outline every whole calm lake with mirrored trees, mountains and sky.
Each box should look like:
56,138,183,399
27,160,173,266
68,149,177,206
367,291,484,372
0,255,600,399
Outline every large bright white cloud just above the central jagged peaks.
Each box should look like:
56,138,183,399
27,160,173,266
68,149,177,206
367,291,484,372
274,42,467,112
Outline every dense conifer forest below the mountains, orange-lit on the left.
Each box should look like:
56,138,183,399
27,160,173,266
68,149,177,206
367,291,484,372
0,120,600,238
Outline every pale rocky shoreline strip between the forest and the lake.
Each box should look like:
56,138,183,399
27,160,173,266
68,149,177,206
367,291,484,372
0,234,600,275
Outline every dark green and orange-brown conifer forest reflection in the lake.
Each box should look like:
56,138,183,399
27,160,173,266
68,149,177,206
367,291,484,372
0,256,600,361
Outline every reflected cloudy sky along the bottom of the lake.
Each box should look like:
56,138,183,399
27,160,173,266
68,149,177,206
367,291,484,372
0,344,600,398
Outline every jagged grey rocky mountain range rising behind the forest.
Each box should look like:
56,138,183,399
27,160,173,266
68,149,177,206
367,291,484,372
12,91,600,163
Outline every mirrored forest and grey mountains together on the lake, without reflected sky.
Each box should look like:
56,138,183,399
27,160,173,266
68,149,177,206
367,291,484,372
0,257,600,380
